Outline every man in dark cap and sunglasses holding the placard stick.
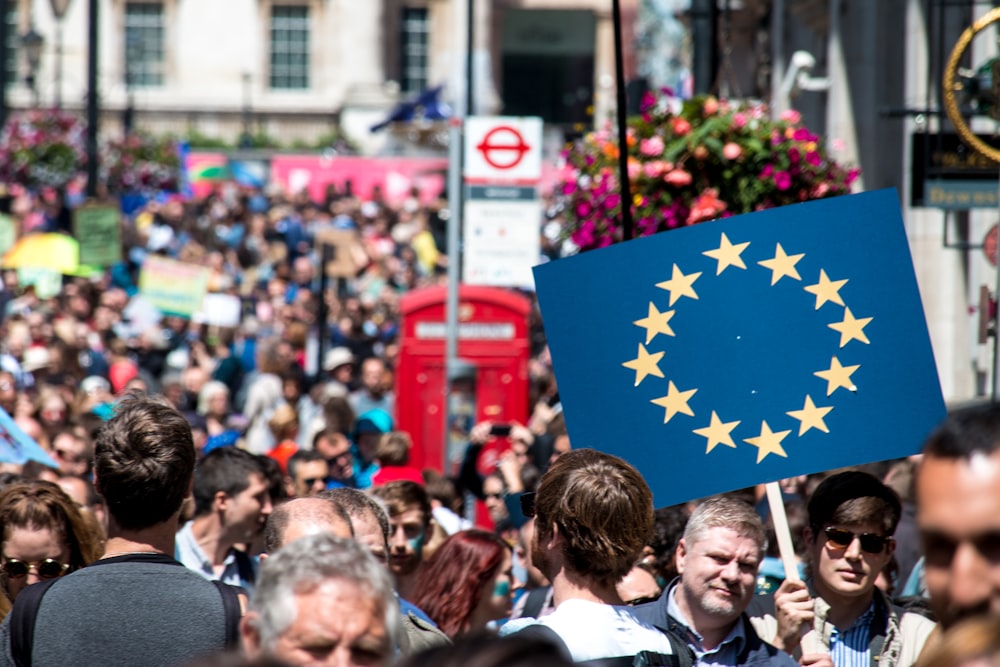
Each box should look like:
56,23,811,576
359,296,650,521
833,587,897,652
755,470,934,667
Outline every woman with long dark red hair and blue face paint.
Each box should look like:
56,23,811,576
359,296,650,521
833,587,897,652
411,530,511,639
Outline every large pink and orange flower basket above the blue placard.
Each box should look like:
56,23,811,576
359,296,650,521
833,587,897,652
562,91,859,250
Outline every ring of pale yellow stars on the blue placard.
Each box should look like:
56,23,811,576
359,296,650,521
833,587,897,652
622,233,873,464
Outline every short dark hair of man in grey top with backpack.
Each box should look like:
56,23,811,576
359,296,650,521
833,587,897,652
94,392,195,530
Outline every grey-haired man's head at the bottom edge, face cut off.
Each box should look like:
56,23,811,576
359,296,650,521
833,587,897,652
240,534,400,667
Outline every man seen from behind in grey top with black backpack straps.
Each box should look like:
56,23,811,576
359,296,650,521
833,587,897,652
0,394,240,667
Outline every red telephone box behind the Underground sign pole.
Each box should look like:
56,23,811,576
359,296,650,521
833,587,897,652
396,285,531,474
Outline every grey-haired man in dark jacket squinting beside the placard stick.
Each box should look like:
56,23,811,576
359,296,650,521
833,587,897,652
635,496,796,667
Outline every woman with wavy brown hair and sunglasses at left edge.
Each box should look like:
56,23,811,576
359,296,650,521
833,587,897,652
0,481,101,617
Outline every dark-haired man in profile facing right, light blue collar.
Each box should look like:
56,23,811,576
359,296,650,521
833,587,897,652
176,447,271,591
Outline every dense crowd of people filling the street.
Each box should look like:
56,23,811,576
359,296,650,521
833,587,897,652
0,181,1000,667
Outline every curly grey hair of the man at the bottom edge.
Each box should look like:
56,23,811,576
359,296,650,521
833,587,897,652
250,534,402,657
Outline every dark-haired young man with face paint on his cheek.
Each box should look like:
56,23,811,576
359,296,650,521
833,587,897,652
371,480,431,599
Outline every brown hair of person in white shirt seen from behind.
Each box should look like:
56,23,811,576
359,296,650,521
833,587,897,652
535,449,653,585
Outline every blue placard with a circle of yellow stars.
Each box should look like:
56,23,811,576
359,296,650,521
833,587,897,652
535,190,945,506
